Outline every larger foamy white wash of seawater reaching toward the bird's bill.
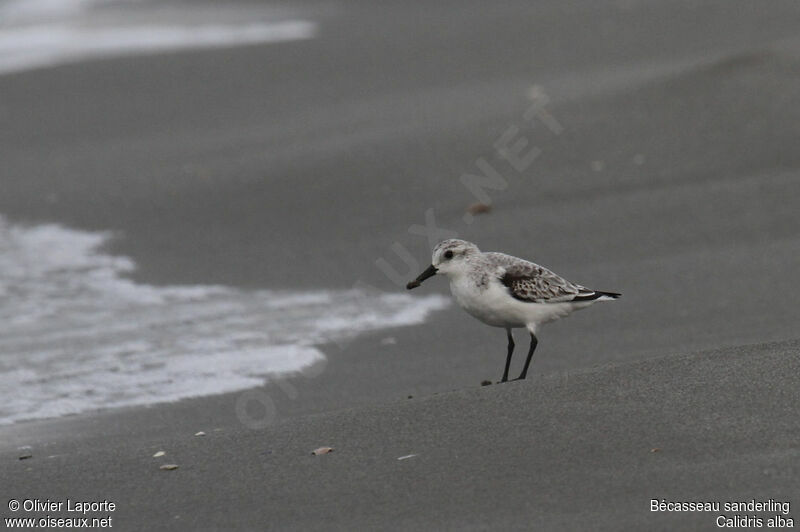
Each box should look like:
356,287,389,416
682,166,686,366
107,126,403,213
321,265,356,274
0,217,448,424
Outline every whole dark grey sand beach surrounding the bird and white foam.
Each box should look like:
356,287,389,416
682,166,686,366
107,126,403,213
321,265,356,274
0,1,800,530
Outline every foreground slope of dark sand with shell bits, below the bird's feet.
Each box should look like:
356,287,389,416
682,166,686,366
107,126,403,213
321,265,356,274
6,341,800,530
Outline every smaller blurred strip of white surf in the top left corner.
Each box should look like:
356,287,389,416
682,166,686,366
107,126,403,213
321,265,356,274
0,0,317,74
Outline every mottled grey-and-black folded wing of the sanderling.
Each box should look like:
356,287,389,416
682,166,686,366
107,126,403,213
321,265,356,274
484,253,599,303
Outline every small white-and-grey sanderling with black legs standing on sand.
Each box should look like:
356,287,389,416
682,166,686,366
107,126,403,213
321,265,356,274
406,239,621,382
